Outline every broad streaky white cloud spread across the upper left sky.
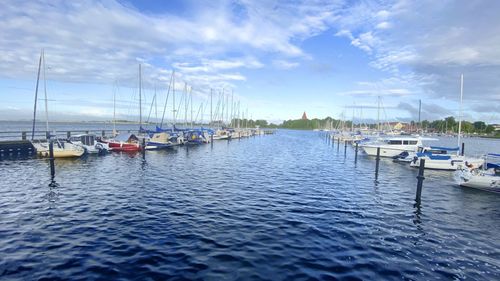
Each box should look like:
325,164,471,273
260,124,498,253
0,0,337,88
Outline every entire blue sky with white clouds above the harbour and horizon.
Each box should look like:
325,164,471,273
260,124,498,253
0,0,500,123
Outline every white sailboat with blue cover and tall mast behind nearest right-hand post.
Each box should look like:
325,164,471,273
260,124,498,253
410,74,484,168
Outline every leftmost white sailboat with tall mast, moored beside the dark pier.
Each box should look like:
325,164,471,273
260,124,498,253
31,49,85,158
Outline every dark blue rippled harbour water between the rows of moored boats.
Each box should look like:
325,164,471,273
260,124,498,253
0,128,500,280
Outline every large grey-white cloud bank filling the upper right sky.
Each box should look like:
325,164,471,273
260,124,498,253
336,0,500,103
